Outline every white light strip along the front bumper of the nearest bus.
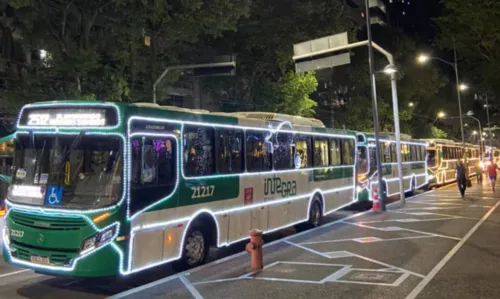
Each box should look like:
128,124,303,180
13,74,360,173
2,210,120,272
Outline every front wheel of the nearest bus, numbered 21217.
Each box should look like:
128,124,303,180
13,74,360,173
173,224,210,271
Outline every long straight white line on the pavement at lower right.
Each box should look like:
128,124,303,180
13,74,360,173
406,201,500,299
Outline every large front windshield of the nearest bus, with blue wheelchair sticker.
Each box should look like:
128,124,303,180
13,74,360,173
8,134,123,209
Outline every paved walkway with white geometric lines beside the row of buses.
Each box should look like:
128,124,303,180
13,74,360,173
111,185,500,299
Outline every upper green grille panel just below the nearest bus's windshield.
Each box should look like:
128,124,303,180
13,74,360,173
9,211,87,231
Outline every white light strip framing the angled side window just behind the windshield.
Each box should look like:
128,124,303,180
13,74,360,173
126,132,182,220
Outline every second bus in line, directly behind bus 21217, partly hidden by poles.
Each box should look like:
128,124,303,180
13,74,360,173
358,133,427,198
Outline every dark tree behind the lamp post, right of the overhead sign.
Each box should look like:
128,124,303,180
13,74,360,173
332,26,447,136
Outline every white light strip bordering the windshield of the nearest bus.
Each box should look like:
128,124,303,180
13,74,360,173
5,131,128,214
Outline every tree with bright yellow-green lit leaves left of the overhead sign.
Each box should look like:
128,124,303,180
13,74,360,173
199,0,355,116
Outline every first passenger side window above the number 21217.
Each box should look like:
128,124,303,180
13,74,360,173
183,125,215,176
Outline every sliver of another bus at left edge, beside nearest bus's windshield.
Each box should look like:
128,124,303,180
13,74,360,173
0,134,14,216
